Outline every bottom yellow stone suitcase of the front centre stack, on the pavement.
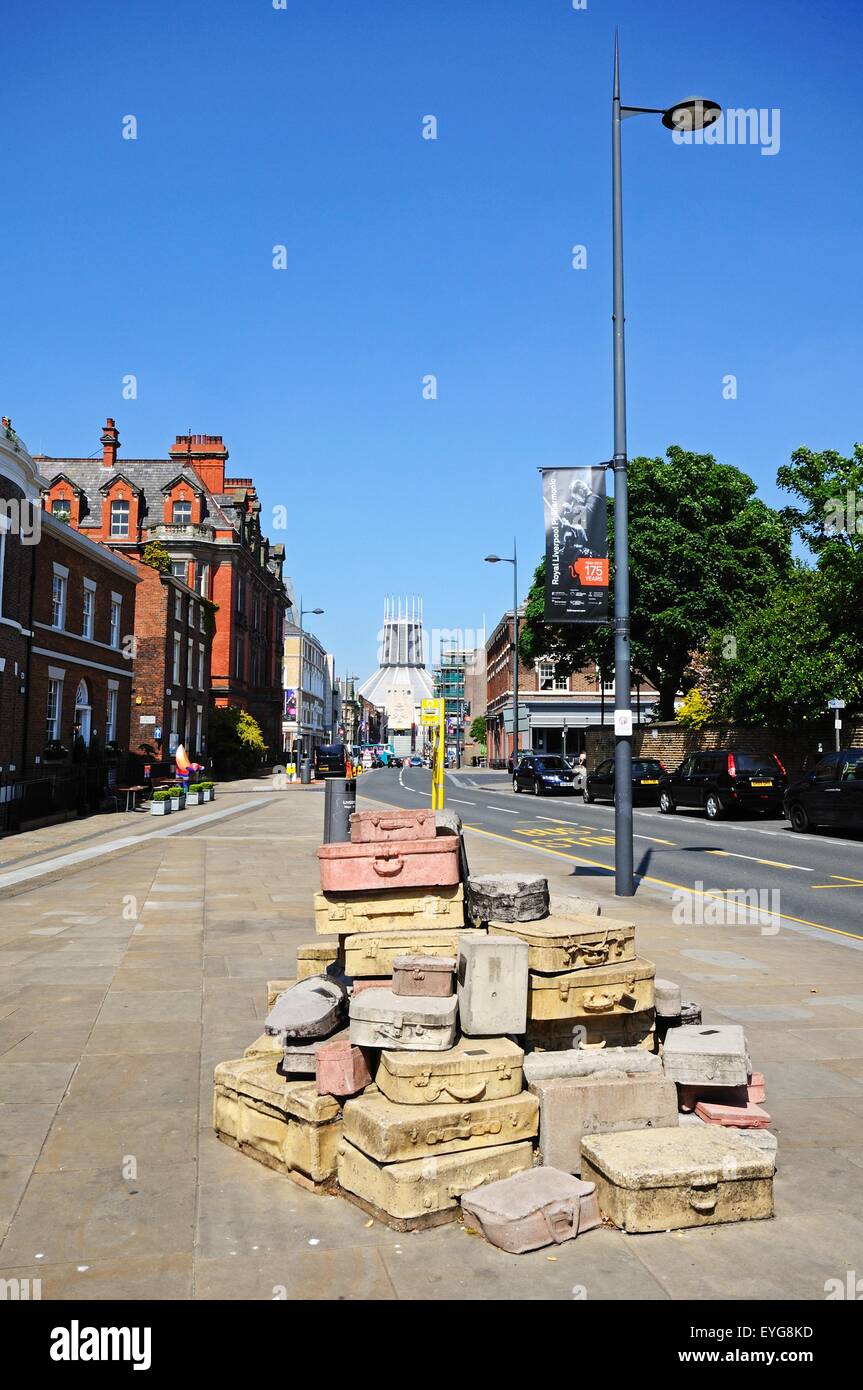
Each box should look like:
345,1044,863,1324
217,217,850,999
338,1138,530,1230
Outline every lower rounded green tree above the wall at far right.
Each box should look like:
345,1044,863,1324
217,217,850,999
707,566,863,728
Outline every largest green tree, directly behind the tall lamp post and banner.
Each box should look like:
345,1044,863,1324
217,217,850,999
520,445,791,719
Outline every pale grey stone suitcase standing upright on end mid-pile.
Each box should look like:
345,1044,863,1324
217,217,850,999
459,933,528,1037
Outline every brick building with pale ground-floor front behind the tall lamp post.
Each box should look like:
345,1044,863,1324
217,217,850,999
486,607,659,766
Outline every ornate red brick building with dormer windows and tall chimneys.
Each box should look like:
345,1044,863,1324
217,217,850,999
38,418,288,749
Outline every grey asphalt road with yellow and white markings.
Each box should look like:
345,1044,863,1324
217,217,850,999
357,769,863,938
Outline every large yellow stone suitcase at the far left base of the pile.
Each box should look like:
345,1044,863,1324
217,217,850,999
213,1056,342,1190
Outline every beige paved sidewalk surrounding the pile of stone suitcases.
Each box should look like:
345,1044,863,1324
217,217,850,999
0,784,863,1300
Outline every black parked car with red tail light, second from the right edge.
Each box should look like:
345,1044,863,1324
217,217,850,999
659,748,788,820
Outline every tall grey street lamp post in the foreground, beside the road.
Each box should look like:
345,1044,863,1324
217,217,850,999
611,33,721,898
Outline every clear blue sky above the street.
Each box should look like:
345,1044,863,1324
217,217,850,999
0,0,863,674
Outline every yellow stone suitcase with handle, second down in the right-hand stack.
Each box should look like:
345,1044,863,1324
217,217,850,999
528,956,656,1020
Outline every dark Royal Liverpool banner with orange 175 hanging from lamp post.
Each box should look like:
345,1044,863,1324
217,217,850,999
541,468,609,623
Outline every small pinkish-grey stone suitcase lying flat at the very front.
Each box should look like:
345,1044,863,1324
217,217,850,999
461,1168,600,1255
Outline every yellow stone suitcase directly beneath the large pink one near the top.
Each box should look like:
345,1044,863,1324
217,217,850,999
314,884,464,937
